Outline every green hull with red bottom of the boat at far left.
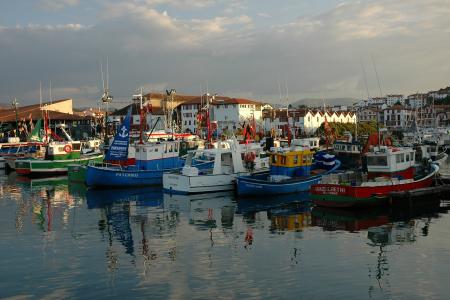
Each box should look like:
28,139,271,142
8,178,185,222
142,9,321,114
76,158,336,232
15,155,103,176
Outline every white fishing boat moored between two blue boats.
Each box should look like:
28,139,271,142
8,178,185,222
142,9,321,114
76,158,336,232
163,140,268,194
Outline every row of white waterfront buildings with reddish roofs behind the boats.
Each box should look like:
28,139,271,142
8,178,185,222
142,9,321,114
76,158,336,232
106,94,356,135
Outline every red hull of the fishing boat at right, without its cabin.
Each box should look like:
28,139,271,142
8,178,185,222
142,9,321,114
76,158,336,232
311,165,439,207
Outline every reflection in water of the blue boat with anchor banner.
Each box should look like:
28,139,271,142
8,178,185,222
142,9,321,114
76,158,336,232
86,187,178,274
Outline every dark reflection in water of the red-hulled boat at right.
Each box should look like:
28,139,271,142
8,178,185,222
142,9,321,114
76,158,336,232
312,199,448,295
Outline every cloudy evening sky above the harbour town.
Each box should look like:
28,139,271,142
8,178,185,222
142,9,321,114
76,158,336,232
0,0,450,107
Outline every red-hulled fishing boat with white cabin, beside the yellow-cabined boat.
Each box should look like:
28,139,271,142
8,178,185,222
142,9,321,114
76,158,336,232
311,145,439,207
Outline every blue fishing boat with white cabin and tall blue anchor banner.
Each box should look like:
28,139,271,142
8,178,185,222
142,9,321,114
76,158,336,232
86,108,212,187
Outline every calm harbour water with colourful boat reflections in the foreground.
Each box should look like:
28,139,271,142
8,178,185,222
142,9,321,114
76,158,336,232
0,169,450,299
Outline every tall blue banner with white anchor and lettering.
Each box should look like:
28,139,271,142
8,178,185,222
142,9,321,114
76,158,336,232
105,109,131,161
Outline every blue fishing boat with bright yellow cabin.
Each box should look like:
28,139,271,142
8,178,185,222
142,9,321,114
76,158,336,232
236,140,341,196
